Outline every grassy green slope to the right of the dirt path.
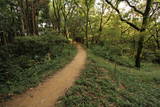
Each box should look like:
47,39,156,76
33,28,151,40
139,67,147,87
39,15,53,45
57,52,160,107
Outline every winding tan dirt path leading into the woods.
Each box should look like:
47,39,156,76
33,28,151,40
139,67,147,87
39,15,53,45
0,45,86,107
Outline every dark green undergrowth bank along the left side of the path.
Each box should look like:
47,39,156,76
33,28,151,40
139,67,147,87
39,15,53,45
0,35,77,100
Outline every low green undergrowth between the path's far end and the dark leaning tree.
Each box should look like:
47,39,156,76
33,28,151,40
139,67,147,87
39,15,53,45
91,42,134,67
